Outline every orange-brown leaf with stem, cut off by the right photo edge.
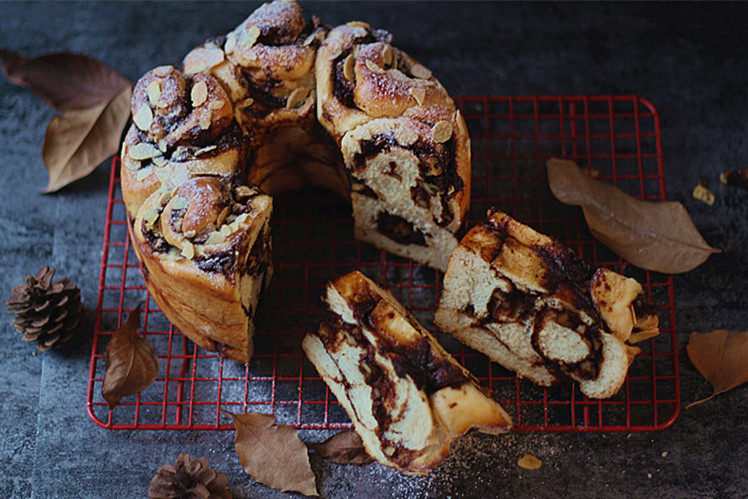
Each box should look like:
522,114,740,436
686,329,748,409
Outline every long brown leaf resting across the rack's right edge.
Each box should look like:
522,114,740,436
547,158,720,274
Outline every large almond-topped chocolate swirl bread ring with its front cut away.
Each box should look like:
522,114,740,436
121,0,470,361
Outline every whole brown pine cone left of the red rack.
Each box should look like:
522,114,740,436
5,265,83,352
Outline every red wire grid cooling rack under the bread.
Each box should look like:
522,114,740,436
86,96,680,431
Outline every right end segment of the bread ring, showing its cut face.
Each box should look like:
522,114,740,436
316,22,470,270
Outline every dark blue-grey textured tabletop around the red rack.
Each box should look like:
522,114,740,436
0,2,748,497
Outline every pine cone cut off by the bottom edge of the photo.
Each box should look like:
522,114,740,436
148,453,231,499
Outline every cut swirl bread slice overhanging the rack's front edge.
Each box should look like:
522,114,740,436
303,271,512,474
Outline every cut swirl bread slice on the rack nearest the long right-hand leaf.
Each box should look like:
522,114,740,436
435,211,657,398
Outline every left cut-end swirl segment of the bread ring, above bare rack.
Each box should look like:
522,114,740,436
132,176,272,363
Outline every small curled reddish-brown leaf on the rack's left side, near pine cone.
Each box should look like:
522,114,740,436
101,303,158,410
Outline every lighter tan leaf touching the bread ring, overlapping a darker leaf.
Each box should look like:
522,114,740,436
42,87,132,192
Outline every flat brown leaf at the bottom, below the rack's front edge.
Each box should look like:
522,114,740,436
229,412,317,496
